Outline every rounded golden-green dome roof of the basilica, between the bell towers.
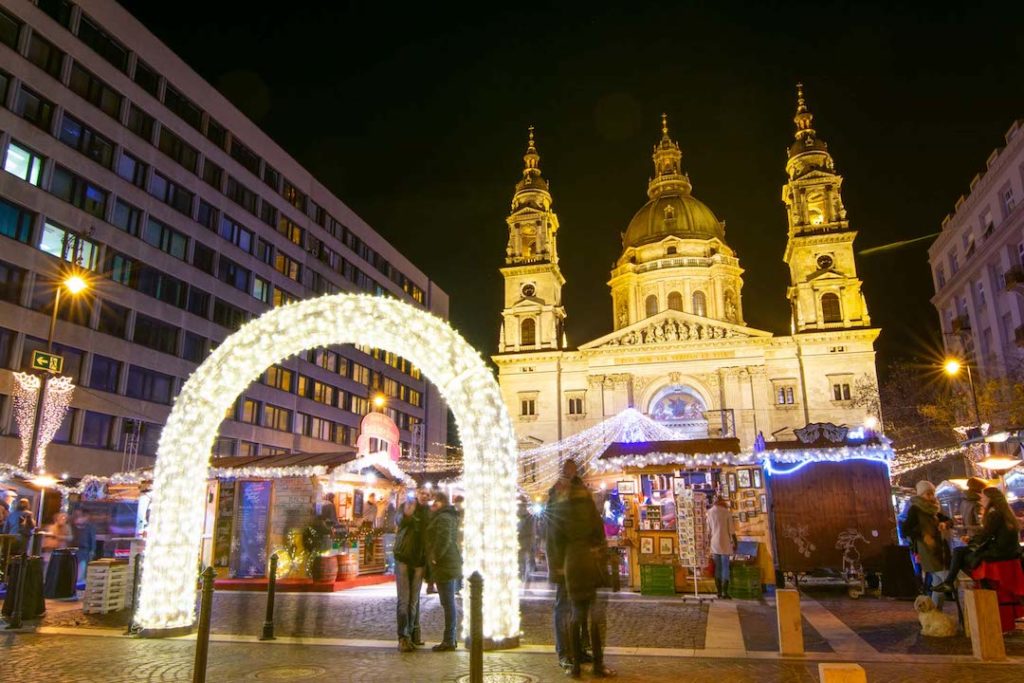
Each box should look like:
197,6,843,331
623,190,725,249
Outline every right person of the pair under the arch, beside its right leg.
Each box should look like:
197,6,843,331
426,490,462,652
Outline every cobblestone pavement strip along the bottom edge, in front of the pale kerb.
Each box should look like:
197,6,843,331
0,635,1020,683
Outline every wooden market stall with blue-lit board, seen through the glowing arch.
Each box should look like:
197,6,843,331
204,453,415,591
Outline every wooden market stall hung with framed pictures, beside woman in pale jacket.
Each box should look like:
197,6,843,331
587,438,774,597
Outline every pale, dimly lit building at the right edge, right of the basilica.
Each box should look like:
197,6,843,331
928,120,1024,378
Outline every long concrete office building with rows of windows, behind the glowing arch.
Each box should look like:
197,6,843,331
0,0,449,475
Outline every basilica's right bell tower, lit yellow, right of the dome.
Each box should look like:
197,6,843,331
782,84,871,333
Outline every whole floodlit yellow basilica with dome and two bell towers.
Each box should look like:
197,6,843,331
493,88,880,449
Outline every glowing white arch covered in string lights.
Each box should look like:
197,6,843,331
135,294,519,641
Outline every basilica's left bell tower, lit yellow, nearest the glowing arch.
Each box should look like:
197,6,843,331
498,126,565,353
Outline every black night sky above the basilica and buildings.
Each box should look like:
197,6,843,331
116,0,1024,368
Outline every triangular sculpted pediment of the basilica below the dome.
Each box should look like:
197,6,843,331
580,310,772,350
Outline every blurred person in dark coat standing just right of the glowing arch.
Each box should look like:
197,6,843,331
553,476,613,678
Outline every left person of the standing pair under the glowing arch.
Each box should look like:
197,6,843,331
394,488,430,652
